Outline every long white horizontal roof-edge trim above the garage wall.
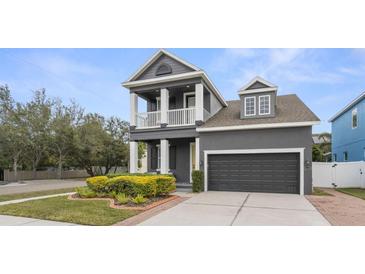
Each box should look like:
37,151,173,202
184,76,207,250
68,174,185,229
196,121,320,132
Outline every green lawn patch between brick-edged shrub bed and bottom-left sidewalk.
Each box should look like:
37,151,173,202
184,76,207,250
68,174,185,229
0,196,138,225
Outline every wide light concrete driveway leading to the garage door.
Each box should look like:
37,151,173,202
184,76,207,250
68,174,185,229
139,191,330,226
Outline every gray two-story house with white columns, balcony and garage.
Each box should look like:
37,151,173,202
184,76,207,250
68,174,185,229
123,50,319,194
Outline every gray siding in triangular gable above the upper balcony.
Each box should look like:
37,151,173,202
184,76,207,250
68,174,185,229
135,55,194,80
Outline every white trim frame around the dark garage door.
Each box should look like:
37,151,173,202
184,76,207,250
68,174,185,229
204,147,305,195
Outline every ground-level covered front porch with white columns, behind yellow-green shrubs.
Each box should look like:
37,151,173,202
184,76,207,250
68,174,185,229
130,137,200,184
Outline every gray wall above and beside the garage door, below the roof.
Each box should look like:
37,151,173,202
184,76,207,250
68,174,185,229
200,127,312,194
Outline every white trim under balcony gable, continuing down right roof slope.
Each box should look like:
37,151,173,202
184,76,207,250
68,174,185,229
122,70,228,106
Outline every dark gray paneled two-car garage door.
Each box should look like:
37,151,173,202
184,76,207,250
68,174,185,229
208,153,299,194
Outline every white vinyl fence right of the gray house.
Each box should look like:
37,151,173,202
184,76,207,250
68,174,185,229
312,161,365,188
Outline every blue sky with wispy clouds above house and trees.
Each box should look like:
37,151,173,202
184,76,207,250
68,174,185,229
0,49,365,132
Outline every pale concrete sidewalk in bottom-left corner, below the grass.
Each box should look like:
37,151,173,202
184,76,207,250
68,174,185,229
0,215,77,226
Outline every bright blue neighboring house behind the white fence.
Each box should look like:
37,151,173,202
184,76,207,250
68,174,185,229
329,92,365,162
